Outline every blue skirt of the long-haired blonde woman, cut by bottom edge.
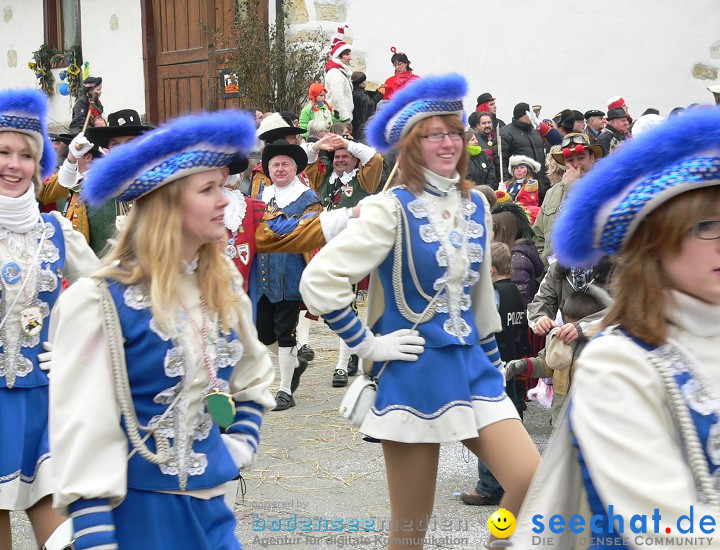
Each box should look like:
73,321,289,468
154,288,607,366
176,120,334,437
113,489,242,550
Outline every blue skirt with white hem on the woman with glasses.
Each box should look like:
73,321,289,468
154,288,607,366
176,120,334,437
360,345,519,443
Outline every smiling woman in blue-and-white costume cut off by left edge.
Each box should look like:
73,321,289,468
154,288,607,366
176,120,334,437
0,90,98,550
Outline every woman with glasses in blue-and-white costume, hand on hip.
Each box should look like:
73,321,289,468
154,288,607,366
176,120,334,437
301,75,539,549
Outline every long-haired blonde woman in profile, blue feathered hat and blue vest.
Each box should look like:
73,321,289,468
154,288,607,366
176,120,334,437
51,111,296,550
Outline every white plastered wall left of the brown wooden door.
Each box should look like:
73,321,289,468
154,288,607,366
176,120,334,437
0,0,145,128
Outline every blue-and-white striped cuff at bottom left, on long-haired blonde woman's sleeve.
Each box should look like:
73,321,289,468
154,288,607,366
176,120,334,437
69,498,117,550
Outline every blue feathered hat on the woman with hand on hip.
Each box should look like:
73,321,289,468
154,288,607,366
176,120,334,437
365,73,468,153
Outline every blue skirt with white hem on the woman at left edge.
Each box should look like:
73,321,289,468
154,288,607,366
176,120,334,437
0,386,52,510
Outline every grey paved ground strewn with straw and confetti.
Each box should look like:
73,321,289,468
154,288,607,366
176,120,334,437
12,308,550,550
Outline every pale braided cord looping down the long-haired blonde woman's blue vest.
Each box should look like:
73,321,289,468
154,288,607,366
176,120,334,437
98,281,171,464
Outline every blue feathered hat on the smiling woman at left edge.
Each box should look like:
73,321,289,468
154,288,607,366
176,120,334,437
0,89,57,179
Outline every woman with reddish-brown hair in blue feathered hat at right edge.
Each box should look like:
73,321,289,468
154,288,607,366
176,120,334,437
512,108,720,550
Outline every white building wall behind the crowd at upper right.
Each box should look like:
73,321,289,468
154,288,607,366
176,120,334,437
286,0,720,122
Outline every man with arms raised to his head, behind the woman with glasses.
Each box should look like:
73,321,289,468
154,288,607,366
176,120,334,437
305,136,383,388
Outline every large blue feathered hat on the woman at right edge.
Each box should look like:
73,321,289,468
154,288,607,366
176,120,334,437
552,107,720,267
